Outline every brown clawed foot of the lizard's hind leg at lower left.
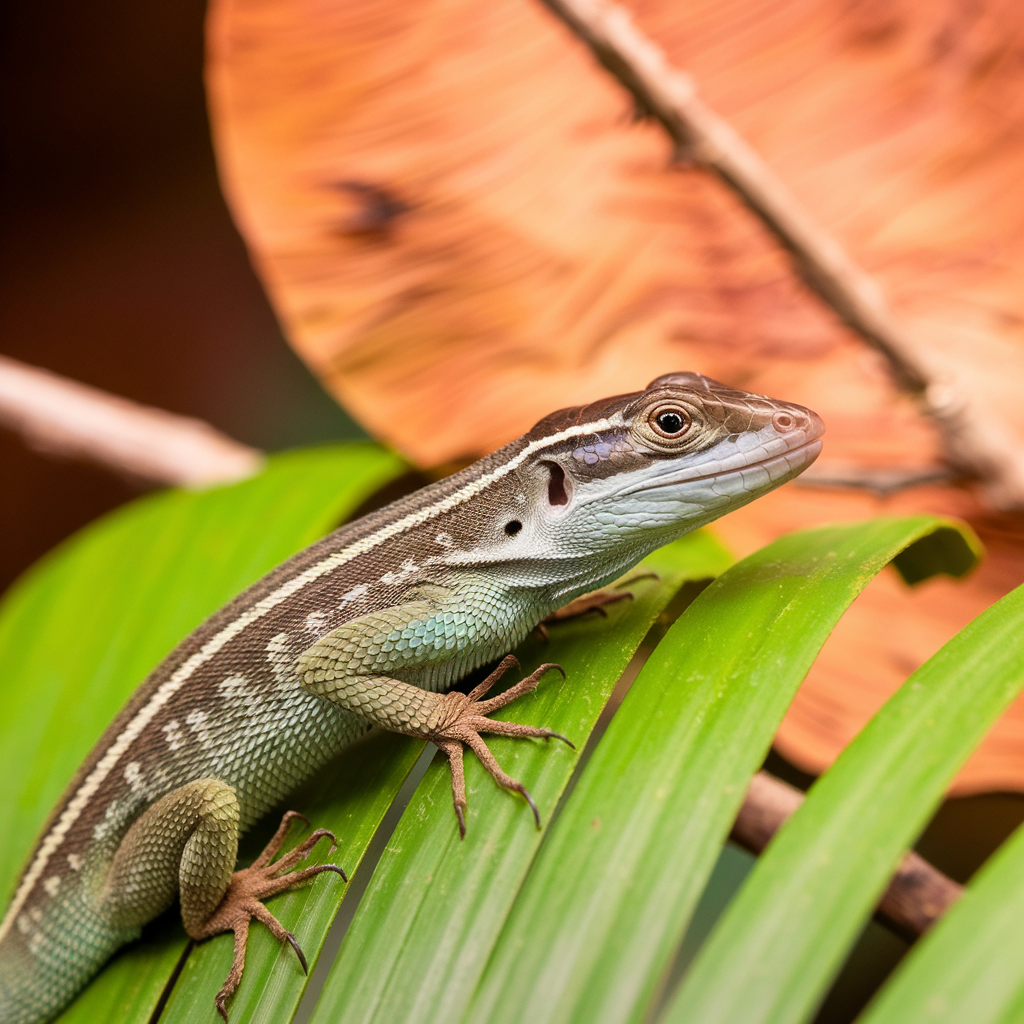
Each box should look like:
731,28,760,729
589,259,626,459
194,811,348,1022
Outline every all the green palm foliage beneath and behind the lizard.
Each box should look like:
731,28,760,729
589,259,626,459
6,444,1024,1024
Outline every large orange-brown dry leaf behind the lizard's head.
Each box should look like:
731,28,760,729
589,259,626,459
209,0,1024,790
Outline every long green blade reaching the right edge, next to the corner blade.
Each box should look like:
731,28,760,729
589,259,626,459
665,588,1024,1024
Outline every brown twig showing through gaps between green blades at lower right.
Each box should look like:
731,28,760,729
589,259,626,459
731,771,964,942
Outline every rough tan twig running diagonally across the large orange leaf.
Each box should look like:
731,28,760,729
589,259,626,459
543,0,1024,510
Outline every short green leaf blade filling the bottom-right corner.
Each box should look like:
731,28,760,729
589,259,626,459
859,815,1024,1024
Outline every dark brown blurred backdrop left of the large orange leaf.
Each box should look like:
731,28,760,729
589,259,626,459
0,0,358,590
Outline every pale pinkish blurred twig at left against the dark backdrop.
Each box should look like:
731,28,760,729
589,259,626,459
0,356,263,487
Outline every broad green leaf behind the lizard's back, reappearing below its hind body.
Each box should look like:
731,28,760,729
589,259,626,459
0,443,402,1021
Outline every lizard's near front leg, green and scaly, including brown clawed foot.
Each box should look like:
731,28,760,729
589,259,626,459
298,588,572,837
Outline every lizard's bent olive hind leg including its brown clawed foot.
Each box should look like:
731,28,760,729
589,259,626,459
100,778,347,1021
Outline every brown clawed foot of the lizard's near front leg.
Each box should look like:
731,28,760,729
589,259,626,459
429,654,575,839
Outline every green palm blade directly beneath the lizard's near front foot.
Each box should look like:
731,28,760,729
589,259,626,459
307,534,729,1024
